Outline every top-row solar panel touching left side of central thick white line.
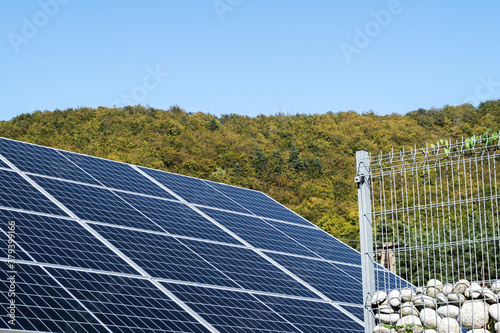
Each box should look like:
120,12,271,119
61,151,175,199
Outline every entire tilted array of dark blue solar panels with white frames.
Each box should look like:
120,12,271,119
0,138,402,332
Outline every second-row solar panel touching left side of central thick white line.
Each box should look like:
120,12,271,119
116,192,241,245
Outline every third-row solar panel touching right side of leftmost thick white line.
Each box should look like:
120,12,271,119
93,225,237,287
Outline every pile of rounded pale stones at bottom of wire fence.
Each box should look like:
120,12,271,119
371,279,500,333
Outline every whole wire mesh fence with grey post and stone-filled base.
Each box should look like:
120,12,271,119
356,133,500,332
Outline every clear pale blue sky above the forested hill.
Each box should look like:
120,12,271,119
0,0,500,120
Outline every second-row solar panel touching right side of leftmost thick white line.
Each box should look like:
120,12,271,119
31,176,162,231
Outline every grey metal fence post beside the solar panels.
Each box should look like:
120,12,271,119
355,150,375,333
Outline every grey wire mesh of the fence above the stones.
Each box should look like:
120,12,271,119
371,137,500,286
